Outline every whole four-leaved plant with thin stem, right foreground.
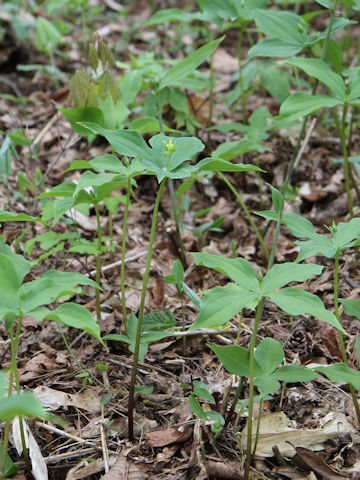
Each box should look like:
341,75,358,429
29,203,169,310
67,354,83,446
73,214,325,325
190,248,345,478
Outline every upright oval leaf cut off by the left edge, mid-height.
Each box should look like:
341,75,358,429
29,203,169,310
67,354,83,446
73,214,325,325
0,253,20,317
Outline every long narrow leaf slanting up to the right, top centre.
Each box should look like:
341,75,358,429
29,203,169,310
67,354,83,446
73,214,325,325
159,36,225,89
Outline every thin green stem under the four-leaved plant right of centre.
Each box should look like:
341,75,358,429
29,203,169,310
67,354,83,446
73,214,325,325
244,297,265,479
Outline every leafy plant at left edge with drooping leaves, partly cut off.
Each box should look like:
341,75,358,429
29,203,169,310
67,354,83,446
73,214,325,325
0,244,103,478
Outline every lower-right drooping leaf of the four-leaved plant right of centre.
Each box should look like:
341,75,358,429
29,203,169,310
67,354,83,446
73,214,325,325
267,288,346,333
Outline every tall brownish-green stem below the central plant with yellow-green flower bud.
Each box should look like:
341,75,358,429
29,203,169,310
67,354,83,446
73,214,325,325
128,178,167,442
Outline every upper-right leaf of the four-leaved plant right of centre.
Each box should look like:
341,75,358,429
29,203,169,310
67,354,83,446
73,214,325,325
262,262,324,295
